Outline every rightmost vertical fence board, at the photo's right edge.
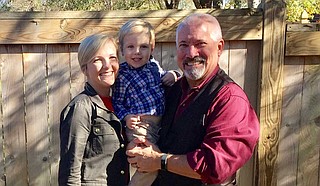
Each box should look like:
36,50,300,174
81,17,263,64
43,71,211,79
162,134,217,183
298,56,320,186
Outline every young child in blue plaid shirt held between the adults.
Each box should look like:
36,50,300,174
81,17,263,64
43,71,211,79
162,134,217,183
112,19,180,186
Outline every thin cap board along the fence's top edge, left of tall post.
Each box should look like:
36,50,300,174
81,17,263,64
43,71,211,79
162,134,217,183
0,8,263,20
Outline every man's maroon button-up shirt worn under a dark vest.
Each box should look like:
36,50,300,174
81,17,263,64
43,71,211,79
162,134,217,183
176,67,259,183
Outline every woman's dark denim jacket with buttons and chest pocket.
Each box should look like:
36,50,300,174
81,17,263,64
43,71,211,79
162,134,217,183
58,83,129,186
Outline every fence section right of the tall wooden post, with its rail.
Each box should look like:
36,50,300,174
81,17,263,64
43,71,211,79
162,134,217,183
275,23,320,186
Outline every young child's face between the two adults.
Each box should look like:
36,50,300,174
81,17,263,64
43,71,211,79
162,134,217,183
122,31,153,68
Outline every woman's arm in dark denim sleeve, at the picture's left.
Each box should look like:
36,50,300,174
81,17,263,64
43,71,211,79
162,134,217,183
59,103,91,185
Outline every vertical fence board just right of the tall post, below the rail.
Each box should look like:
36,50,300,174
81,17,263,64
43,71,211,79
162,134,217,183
277,57,304,186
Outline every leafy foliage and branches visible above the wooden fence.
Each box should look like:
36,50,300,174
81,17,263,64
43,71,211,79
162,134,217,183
0,0,320,22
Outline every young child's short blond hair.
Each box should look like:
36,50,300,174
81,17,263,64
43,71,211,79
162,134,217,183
119,19,156,52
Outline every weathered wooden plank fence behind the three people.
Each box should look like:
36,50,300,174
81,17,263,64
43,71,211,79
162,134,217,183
0,5,320,186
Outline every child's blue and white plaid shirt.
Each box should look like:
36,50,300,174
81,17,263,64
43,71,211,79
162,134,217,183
112,59,166,120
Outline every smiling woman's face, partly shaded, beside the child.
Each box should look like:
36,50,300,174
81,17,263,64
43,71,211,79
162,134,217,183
85,41,119,96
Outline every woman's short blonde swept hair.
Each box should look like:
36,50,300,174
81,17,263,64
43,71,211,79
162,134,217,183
78,34,119,72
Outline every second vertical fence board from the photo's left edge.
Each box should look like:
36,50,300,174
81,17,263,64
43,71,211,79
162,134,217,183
23,45,50,185
